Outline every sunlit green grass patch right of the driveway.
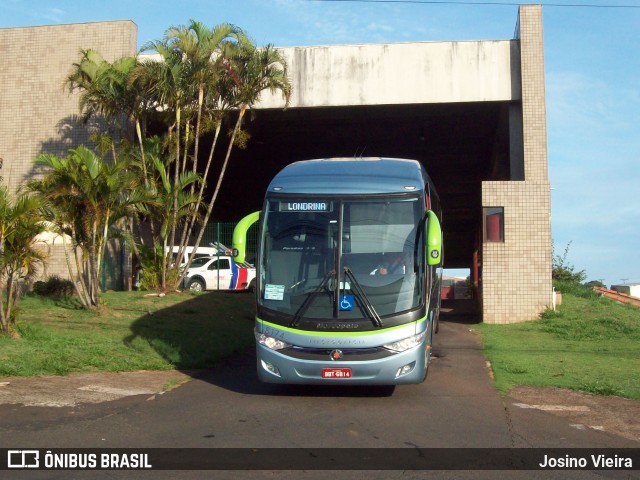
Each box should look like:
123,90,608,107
477,285,640,400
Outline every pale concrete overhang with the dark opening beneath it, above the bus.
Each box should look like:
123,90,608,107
144,40,522,268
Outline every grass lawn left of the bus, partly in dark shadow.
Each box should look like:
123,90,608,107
0,292,255,376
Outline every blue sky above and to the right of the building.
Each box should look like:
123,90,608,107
0,0,640,285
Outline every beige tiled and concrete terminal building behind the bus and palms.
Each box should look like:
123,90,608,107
0,5,552,323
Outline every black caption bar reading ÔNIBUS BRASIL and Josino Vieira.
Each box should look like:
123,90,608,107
0,447,640,471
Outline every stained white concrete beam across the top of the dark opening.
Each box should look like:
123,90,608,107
255,40,521,109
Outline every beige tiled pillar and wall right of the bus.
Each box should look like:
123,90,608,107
481,5,552,323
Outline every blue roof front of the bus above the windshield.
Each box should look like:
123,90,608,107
267,157,428,194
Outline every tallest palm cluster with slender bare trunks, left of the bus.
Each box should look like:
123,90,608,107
67,20,291,288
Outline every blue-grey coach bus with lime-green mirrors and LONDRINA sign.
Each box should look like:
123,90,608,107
233,158,443,385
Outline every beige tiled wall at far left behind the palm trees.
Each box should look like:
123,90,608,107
0,21,137,284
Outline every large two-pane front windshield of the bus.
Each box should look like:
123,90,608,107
258,195,425,324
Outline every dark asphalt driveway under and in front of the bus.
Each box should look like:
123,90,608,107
0,317,640,479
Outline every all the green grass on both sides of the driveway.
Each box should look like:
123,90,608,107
0,287,640,400
